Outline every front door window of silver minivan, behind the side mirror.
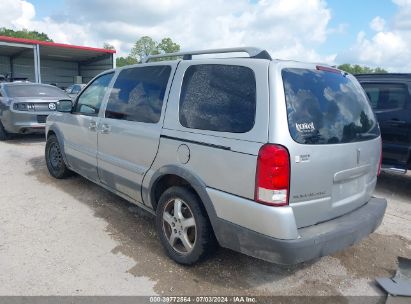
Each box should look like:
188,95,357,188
74,73,114,115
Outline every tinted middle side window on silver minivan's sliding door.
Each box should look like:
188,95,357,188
105,65,171,123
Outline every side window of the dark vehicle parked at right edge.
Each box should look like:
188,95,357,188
362,83,408,110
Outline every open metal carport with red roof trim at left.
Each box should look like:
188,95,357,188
0,36,116,88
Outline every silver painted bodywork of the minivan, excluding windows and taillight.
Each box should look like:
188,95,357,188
47,52,381,262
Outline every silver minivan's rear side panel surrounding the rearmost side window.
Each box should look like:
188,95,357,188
150,59,269,199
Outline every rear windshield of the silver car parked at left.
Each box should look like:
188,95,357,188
5,84,67,98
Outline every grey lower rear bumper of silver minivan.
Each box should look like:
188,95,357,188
214,198,387,264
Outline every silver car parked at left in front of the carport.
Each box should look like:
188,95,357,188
0,82,68,140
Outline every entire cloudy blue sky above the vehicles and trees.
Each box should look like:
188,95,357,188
0,0,411,71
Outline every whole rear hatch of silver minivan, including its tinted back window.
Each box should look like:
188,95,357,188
281,66,381,227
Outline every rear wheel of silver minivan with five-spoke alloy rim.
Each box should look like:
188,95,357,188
156,187,217,265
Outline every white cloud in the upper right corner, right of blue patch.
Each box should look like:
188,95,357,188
336,0,411,72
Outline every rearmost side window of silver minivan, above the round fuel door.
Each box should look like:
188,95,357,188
179,64,256,133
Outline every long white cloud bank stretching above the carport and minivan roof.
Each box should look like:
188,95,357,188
0,0,335,62
